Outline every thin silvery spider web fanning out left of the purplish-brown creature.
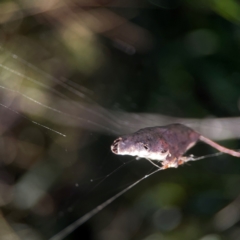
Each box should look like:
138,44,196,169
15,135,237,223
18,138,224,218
0,44,236,240
